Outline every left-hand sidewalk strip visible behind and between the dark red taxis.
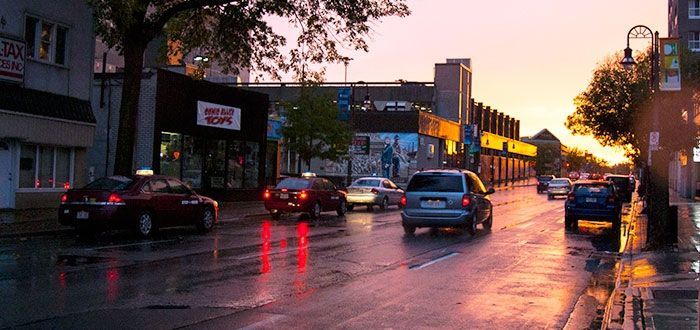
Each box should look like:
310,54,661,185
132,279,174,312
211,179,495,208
0,201,267,237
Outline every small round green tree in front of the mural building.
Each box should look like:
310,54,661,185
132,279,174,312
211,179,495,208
280,87,352,167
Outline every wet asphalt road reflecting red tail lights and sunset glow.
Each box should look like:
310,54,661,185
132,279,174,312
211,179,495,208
0,187,624,329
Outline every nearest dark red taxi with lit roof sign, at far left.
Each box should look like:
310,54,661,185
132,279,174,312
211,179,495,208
58,175,219,237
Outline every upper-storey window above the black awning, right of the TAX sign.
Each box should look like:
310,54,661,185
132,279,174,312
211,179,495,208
24,16,68,65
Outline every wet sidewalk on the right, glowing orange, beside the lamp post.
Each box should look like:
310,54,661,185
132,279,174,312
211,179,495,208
603,192,700,329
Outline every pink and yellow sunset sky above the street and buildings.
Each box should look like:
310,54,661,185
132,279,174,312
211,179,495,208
270,0,668,163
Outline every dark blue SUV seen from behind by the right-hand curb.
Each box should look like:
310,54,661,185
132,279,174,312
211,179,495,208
564,180,622,232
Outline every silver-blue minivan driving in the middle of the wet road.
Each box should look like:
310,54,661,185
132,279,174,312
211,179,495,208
401,170,494,235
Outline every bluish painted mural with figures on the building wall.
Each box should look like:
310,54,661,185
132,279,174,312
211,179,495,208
324,133,418,181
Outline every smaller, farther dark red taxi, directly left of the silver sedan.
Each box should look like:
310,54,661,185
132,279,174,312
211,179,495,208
263,177,347,219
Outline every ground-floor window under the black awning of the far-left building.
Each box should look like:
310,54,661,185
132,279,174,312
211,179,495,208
19,144,74,189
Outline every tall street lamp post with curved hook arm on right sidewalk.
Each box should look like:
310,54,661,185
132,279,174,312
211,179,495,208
620,25,669,245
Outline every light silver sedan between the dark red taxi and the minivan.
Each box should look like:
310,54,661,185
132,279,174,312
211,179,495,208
346,177,403,211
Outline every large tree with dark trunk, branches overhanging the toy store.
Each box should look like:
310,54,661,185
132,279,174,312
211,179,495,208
87,0,410,174
